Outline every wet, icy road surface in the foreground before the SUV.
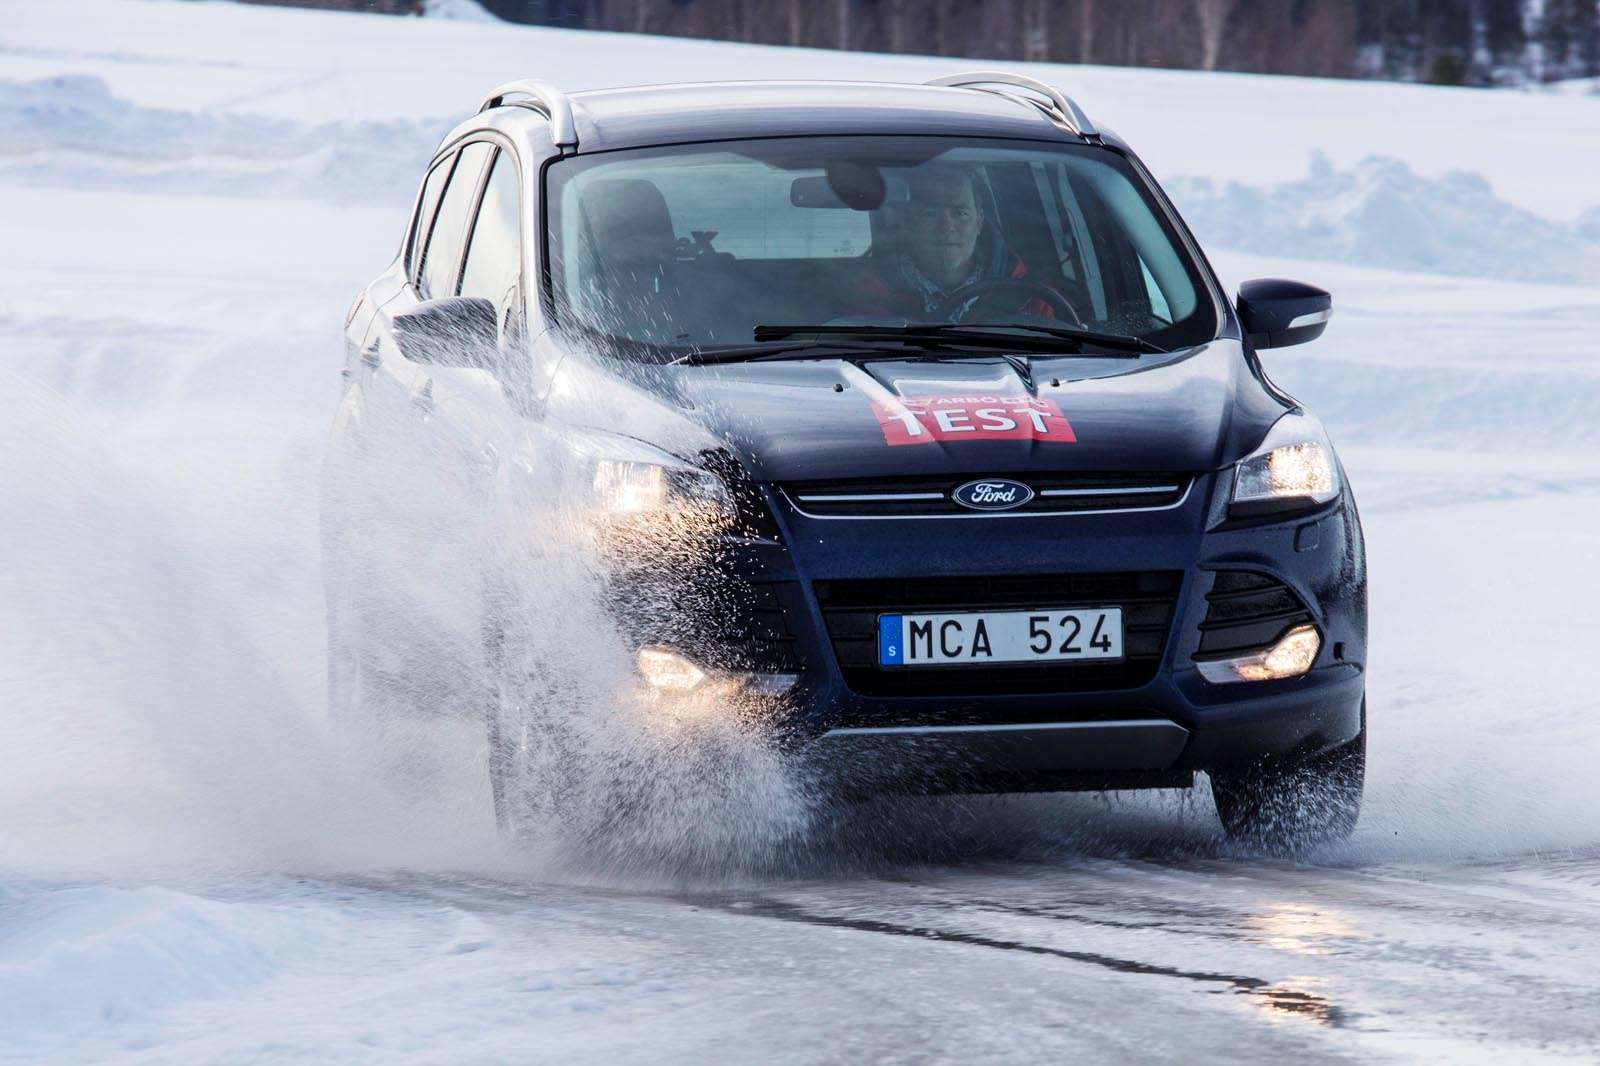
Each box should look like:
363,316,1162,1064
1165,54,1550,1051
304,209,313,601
9,851,1600,1063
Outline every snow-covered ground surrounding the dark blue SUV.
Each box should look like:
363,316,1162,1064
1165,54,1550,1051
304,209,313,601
0,0,1600,1063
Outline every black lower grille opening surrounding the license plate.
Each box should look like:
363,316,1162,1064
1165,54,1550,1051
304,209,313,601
814,570,1182,696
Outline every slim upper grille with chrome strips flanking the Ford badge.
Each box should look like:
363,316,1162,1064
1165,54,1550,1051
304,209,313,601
782,471,1190,519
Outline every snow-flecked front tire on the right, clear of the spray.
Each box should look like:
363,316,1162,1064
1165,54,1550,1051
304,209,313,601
1211,701,1366,853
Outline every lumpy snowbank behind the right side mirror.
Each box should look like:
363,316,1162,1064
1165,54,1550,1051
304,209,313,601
1168,152,1600,283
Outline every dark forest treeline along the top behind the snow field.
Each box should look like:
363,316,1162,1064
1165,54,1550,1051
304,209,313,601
252,0,1600,85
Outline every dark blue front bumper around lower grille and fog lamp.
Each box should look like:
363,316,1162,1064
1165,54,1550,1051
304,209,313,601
665,475,1366,791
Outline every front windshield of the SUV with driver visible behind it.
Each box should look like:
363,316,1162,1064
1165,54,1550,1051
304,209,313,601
546,136,1216,355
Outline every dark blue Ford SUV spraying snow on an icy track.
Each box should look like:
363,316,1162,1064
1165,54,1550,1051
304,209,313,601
325,72,1366,842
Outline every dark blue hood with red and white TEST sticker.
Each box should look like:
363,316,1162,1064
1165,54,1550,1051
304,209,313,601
544,341,1290,482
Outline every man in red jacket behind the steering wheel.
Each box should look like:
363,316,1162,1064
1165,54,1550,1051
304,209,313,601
858,165,1056,320
